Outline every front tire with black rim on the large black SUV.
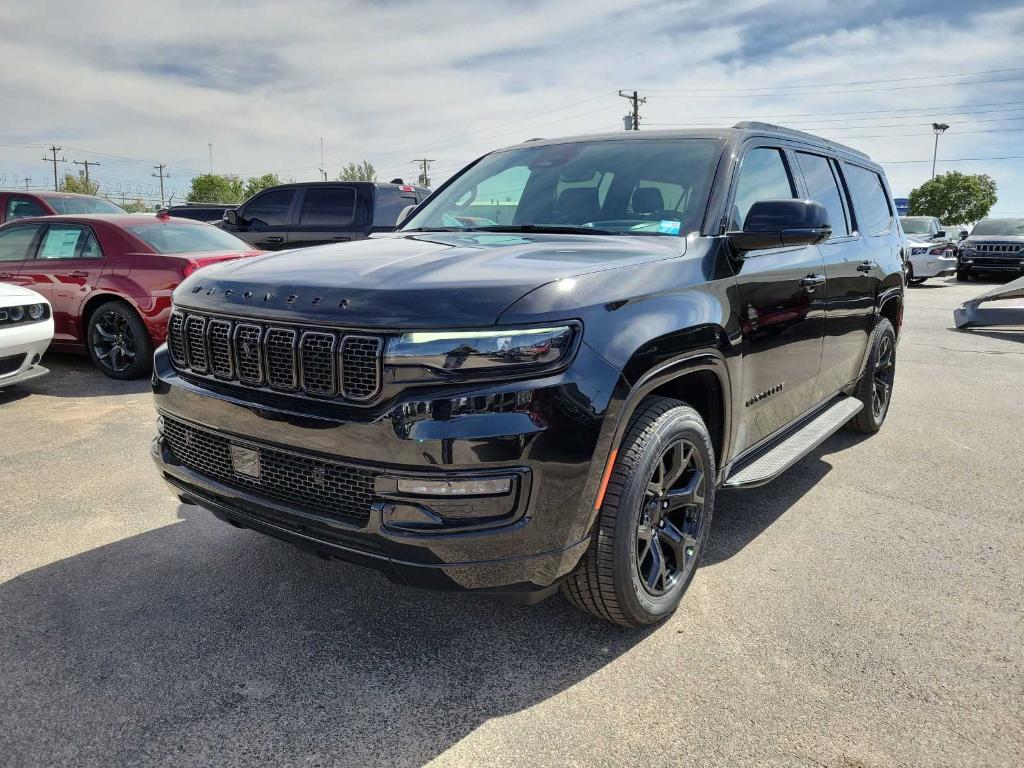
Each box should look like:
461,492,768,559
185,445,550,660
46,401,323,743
561,397,715,627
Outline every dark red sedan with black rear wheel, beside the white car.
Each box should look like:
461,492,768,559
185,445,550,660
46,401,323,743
0,214,262,379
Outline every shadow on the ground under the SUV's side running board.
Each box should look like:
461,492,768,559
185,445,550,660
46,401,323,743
700,431,867,565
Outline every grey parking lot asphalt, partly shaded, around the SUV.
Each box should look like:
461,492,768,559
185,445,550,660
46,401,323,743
0,280,1024,768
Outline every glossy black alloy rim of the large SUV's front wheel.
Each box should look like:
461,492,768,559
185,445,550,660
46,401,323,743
636,440,705,597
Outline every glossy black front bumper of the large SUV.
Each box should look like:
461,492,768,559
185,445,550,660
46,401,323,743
152,345,621,599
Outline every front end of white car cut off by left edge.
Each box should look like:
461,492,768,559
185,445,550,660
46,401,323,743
0,283,53,389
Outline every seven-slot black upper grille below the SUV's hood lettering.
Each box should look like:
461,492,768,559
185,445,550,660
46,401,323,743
167,309,384,402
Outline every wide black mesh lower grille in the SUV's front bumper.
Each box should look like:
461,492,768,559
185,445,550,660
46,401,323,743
163,416,382,522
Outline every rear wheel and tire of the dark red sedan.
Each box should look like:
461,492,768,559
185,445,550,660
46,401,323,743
85,301,153,380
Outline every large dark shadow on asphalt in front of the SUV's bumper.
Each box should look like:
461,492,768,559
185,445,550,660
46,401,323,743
0,506,649,768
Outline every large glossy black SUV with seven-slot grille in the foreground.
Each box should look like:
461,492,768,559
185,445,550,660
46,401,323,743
153,123,903,626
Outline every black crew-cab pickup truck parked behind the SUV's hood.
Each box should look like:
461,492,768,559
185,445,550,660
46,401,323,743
221,181,430,251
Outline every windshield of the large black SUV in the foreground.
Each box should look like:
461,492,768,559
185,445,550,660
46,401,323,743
402,138,722,237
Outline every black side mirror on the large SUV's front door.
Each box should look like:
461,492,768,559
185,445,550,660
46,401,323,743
726,200,831,255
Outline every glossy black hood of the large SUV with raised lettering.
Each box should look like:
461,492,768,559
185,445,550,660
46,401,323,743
174,232,686,328
